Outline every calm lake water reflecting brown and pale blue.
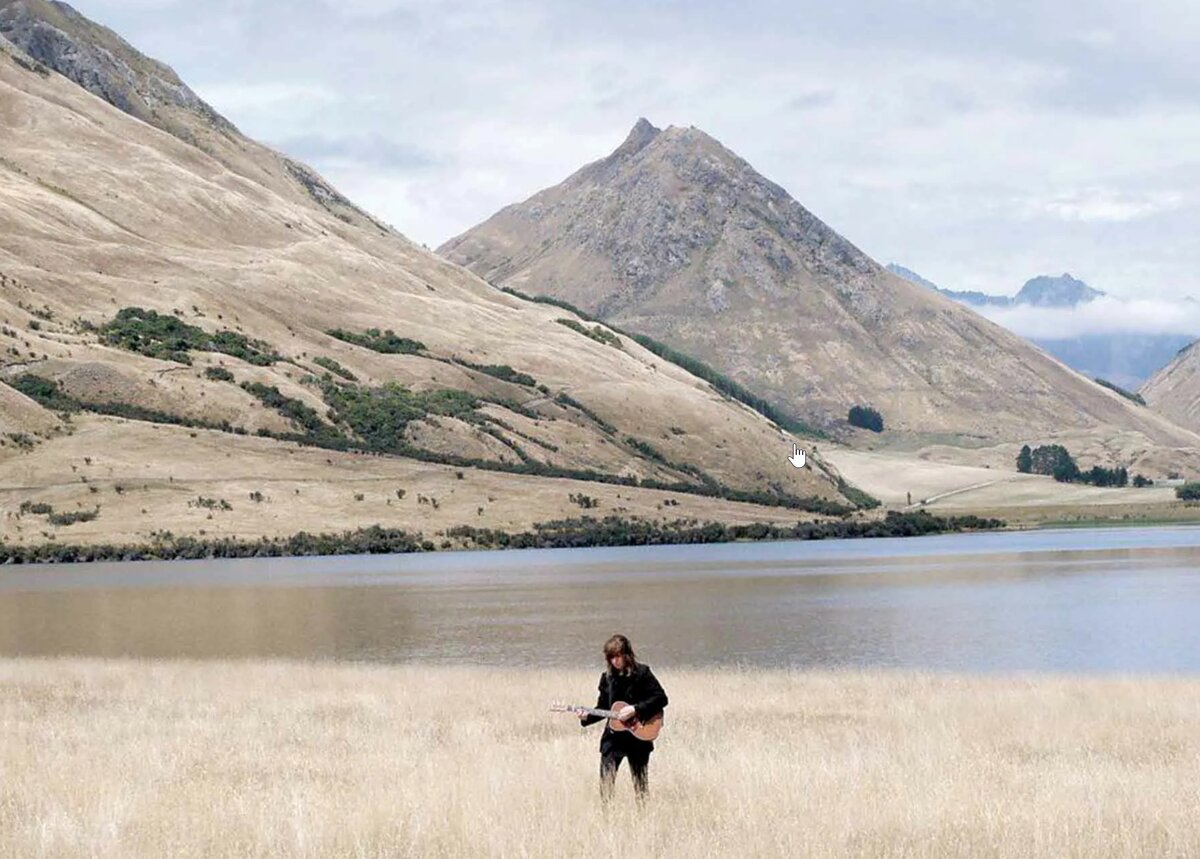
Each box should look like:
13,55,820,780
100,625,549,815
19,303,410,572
0,527,1200,673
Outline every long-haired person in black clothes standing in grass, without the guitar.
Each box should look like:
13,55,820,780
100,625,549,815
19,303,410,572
580,635,667,801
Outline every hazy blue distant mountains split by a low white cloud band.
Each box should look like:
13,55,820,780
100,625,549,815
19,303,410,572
888,263,1194,391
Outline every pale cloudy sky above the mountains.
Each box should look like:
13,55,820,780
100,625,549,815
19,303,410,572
74,0,1200,309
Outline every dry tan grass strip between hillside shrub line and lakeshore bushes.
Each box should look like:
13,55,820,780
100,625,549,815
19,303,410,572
0,416,821,545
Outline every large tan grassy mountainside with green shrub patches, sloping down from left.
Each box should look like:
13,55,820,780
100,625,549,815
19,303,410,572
0,10,850,545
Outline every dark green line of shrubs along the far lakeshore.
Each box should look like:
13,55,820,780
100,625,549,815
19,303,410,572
0,511,1004,564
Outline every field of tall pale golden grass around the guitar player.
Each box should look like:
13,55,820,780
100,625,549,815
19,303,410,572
0,656,1200,857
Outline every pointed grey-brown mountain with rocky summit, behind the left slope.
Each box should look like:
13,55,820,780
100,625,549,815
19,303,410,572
439,119,1196,455
